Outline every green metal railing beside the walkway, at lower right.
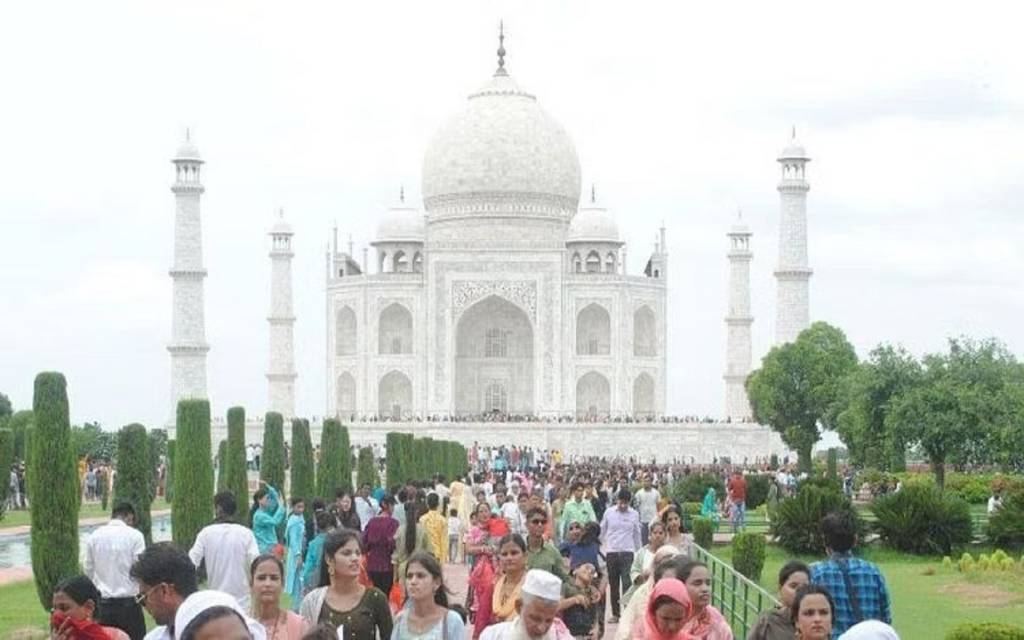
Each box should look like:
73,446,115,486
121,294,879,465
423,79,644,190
692,544,781,638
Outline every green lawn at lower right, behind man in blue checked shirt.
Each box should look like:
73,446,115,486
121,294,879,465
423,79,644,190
712,545,1024,640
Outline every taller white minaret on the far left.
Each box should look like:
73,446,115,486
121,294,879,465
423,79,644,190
167,131,210,425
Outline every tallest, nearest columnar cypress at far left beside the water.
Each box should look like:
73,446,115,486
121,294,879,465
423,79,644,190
28,372,81,610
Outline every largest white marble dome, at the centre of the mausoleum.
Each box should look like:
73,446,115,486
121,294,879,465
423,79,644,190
423,71,580,212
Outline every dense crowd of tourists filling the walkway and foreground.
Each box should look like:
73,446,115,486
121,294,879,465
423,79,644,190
34,446,896,640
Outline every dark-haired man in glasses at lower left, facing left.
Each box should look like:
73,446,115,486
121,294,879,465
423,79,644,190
131,543,198,640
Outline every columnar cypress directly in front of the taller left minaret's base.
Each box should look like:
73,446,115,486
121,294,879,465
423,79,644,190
171,399,213,549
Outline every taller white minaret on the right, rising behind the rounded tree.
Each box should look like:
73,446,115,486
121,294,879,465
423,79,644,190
775,127,812,344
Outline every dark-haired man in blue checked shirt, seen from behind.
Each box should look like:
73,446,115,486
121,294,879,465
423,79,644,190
811,512,893,635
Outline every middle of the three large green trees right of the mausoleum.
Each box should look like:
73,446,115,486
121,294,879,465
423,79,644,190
836,344,922,471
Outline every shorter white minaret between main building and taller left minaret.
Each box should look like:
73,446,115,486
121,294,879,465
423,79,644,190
266,209,297,419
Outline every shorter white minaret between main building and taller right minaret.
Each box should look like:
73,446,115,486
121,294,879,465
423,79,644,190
725,213,754,422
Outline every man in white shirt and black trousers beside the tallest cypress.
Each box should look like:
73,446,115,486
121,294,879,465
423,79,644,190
85,501,145,640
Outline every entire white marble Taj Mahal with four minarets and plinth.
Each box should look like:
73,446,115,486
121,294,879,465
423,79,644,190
168,31,811,462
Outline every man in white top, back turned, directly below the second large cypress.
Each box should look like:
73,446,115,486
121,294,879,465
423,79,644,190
188,492,259,609
